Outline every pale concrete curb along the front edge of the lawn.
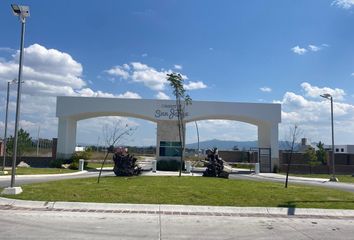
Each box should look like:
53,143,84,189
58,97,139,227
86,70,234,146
0,197,354,218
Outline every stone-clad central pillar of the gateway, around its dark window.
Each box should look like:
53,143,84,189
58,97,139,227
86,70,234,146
156,121,185,160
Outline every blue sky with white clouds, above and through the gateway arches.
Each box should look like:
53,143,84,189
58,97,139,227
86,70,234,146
0,0,354,145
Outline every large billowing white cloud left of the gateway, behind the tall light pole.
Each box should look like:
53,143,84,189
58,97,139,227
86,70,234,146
0,44,141,140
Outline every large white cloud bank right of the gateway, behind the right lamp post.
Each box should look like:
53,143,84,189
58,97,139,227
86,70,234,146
274,83,354,144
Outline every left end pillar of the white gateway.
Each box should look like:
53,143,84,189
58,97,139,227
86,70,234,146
57,117,77,159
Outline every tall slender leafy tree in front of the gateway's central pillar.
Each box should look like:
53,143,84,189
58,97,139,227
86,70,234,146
167,73,192,176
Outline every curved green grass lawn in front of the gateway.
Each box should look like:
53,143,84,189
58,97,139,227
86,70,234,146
6,176,354,209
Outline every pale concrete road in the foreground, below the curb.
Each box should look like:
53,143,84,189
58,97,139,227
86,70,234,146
0,210,354,240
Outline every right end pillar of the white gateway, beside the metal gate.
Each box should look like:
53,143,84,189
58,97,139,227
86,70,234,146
258,123,279,170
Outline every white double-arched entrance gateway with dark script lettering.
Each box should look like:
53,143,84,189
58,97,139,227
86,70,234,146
56,97,281,171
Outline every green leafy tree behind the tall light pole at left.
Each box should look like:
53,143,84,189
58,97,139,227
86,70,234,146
6,128,32,160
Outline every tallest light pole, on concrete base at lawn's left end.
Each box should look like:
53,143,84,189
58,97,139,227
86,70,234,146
3,4,30,194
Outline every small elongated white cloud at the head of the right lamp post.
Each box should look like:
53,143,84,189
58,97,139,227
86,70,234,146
301,82,346,101
